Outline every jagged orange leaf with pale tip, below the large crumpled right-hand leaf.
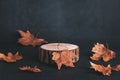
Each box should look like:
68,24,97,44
90,62,111,76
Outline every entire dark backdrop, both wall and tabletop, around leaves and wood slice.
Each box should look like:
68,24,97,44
0,0,120,80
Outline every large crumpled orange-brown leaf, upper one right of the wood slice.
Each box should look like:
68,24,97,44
90,43,116,62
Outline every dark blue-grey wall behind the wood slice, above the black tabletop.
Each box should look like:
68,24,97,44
0,0,120,47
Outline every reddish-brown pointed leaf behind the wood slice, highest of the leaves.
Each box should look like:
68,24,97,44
17,30,46,47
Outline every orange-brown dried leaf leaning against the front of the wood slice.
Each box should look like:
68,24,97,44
52,50,78,70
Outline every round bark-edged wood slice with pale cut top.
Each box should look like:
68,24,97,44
39,43,79,64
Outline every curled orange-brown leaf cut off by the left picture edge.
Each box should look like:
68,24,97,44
0,52,22,62
